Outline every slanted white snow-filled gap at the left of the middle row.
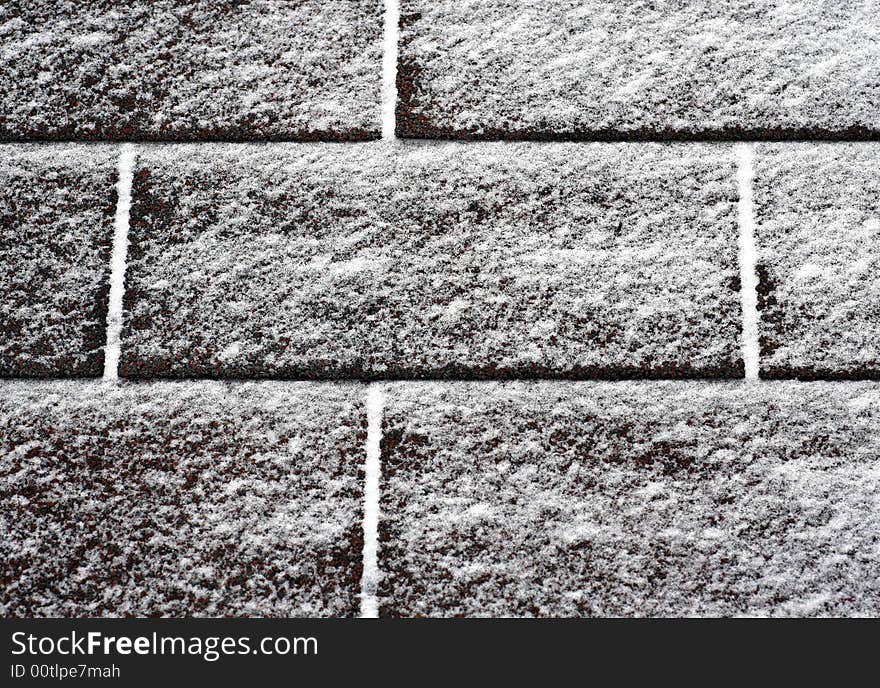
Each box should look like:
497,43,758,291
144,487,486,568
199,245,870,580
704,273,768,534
104,143,136,380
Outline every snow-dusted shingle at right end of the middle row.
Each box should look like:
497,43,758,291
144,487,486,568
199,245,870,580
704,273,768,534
755,143,880,379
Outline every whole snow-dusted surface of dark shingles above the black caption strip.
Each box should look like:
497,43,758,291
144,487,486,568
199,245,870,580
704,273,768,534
0,0,880,617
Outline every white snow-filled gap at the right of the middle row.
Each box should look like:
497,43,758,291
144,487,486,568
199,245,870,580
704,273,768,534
737,143,760,381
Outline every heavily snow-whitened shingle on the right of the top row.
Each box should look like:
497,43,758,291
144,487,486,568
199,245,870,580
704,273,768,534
398,0,880,139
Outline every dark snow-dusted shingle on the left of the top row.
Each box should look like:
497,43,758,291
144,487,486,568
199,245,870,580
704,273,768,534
0,0,382,140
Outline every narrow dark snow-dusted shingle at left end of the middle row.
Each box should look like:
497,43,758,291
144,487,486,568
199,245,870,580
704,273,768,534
0,145,118,377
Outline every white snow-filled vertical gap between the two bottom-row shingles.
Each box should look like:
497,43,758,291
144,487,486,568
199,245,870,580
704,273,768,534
361,386,385,619
